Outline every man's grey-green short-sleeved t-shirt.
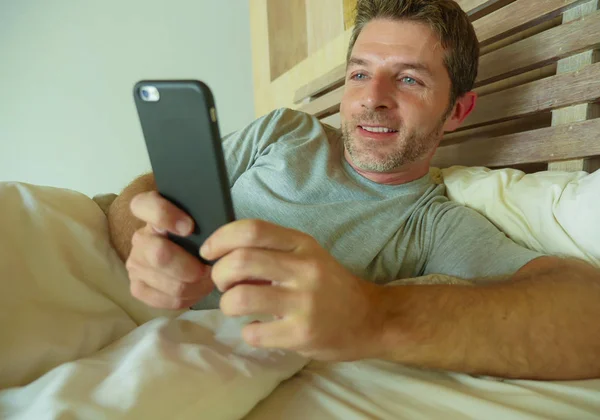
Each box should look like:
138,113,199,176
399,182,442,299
195,109,540,303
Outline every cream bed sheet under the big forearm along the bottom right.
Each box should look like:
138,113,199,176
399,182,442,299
245,360,600,420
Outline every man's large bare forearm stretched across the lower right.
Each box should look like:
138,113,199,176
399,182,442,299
376,260,600,380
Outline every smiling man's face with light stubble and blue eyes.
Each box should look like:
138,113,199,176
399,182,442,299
340,20,451,173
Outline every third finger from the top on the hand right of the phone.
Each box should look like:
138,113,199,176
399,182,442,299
220,285,298,317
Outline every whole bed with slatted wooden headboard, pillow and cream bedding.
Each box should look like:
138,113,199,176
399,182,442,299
0,0,600,420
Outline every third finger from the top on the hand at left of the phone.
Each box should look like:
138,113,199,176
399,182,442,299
131,267,214,300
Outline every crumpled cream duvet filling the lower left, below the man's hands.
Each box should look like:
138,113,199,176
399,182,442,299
0,183,307,419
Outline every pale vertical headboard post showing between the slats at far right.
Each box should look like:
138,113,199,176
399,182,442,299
548,0,600,172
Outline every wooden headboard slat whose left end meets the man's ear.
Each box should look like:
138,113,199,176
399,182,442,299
464,63,600,127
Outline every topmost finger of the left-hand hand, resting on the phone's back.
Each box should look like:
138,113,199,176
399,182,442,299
130,191,194,236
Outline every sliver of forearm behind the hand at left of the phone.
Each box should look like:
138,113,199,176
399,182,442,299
108,173,156,261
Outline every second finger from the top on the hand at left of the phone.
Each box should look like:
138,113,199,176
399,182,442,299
130,231,210,283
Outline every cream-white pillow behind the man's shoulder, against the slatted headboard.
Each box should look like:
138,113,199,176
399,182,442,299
442,166,600,267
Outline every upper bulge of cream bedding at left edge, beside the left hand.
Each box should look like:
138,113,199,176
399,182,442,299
0,183,179,388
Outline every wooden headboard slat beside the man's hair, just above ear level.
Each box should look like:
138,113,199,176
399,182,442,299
477,12,600,85
